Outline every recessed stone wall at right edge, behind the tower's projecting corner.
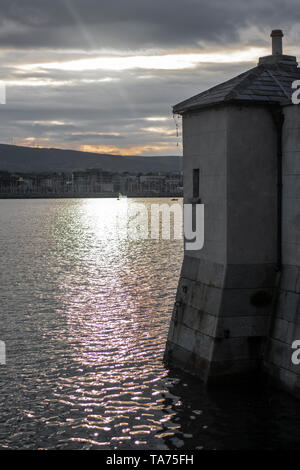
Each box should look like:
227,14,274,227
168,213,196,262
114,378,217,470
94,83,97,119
265,105,300,396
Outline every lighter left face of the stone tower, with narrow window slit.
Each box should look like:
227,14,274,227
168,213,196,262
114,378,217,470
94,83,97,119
165,108,228,380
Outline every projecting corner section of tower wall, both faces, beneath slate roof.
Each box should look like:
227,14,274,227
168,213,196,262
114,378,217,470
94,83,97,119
165,106,277,380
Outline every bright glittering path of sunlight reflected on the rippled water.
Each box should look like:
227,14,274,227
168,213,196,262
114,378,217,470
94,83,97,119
52,199,181,445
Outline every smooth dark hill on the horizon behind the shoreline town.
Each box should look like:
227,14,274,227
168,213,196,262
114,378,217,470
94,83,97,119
0,144,182,173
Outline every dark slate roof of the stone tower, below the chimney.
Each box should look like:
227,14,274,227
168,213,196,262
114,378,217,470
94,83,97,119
173,55,300,114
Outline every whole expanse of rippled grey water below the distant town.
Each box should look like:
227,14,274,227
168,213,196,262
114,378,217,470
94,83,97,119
0,199,300,449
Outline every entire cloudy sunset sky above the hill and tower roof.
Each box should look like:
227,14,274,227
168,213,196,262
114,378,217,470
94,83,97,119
0,0,300,156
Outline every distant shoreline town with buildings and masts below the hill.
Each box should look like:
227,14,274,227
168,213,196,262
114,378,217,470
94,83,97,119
0,168,183,199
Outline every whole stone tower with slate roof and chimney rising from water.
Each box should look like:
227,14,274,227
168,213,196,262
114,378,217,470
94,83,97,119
165,30,300,393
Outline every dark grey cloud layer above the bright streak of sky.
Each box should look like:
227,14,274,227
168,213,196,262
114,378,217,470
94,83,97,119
0,0,300,49
